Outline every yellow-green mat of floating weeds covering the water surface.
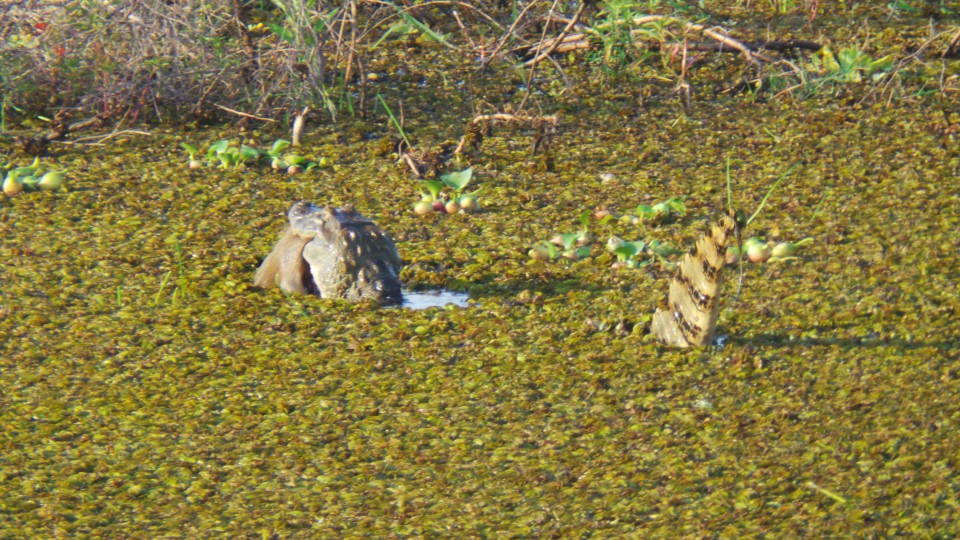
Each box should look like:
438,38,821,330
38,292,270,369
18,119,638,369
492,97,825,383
0,5,960,538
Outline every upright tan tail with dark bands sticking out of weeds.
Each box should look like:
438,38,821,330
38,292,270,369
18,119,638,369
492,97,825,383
650,212,743,347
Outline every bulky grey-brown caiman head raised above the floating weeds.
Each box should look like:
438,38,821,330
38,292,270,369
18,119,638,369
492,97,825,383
254,201,403,304
